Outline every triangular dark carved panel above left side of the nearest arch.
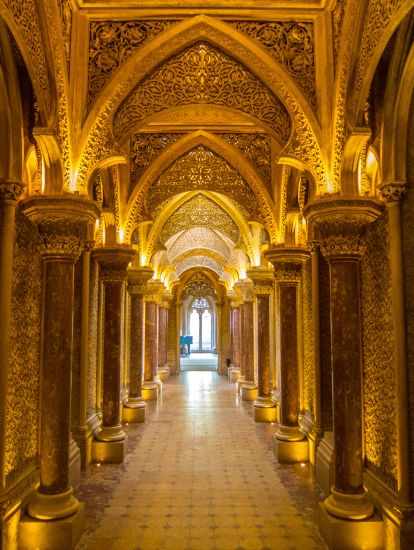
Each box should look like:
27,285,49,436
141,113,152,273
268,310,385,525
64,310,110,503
88,21,174,107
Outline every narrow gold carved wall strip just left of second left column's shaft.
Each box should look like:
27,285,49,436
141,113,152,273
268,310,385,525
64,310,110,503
88,260,99,415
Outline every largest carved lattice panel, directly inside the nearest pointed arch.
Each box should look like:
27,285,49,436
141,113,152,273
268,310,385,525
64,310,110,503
114,42,291,143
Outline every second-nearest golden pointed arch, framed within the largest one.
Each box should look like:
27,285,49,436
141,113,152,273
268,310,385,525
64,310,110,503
125,130,277,243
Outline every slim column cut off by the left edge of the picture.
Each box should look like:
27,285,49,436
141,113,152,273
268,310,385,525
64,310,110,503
0,180,24,487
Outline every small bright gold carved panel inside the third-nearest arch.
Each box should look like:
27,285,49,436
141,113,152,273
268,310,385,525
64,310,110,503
160,195,240,244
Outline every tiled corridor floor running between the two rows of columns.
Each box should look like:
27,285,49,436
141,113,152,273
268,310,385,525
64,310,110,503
75,372,325,550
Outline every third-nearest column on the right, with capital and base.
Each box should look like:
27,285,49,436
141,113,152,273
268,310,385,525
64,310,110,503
247,268,277,422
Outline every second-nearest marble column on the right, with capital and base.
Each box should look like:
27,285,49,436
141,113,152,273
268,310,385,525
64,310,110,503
265,250,309,462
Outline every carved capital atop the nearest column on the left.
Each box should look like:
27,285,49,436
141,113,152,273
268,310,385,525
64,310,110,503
22,195,99,260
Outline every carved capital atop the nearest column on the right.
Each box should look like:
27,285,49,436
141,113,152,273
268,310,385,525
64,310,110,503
305,195,383,259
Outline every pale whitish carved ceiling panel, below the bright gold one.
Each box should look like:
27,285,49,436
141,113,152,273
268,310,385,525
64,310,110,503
166,227,231,262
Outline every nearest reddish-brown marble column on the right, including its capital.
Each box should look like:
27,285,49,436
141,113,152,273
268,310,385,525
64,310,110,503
306,198,381,533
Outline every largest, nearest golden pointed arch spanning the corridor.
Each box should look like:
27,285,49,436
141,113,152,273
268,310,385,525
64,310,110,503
77,15,321,190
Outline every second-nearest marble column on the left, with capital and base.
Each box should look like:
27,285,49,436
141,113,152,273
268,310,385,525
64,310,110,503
93,245,135,462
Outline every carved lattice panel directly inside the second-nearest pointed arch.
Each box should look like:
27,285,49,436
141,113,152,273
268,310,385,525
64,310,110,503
146,145,261,220
